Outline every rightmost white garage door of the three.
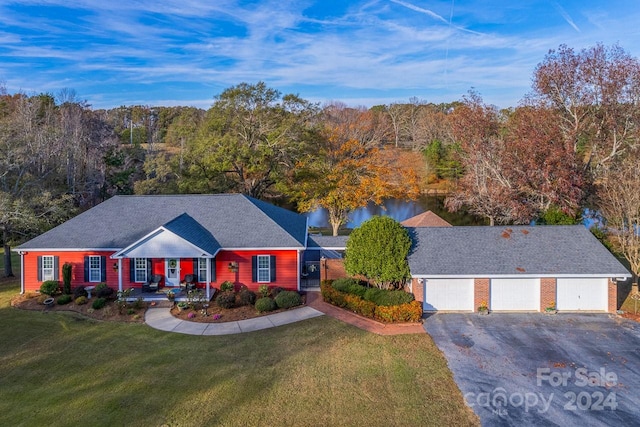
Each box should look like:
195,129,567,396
556,279,609,311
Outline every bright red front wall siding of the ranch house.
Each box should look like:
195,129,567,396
24,250,298,291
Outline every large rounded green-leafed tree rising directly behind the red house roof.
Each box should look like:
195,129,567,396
179,82,317,198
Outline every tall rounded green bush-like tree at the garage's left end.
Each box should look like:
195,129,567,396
344,216,411,289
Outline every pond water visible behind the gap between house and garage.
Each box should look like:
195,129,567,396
305,196,486,228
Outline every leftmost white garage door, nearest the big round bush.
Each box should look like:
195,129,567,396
423,279,473,311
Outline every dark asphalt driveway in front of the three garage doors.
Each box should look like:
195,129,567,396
424,313,640,426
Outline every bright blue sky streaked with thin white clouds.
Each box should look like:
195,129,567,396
0,0,640,109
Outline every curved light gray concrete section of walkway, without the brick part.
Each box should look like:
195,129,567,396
144,307,323,335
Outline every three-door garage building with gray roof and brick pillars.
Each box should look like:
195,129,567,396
408,225,631,312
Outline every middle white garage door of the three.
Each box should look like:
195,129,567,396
490,278,540,311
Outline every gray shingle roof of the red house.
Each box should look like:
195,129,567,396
16,194,307,250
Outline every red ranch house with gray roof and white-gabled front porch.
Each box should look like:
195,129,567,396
16,194,307,297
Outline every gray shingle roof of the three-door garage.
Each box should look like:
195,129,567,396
408,225,630,277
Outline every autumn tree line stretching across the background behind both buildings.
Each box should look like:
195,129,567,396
0,45,640,284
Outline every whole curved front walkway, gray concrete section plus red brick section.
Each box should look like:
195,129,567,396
144,291,425,335
